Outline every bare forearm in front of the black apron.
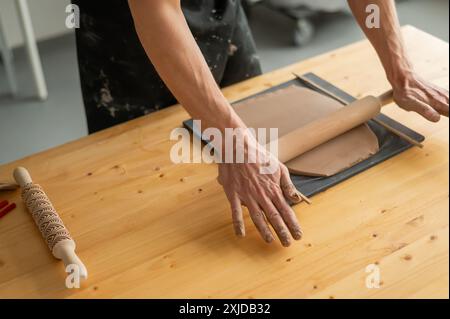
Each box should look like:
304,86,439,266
129,0,244,130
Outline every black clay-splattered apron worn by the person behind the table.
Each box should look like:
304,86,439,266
72,0,261,132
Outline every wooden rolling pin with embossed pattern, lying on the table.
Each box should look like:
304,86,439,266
14,167,87,279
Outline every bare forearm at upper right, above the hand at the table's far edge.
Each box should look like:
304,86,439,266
348,0,413,87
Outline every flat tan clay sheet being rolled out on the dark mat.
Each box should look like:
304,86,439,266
234,85,379,176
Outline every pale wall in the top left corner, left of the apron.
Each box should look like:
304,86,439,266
0,0,72,47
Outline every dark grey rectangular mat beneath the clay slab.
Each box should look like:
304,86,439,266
183,73,425,197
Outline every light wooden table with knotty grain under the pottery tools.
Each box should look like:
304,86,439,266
0,27,449,298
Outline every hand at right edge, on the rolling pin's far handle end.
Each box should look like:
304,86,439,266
393,75,448,122
